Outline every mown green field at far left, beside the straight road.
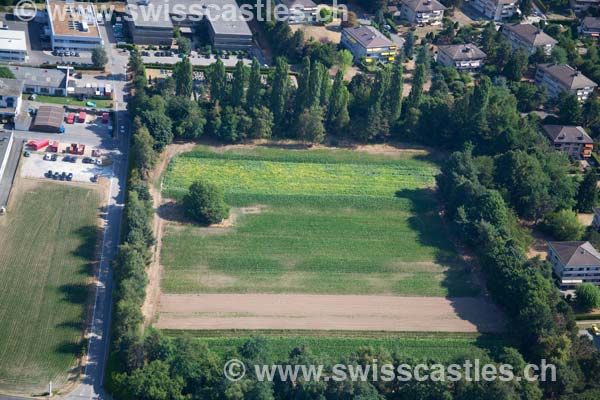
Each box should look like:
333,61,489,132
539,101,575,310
0,183,100,394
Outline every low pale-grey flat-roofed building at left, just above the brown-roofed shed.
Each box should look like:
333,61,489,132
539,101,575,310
8,66,70,96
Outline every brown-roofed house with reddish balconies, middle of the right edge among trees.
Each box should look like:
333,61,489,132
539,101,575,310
542,125,594,158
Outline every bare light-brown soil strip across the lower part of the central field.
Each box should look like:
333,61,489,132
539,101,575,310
155,294,504,332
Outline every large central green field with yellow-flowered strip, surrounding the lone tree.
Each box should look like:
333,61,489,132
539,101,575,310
161,147,477,296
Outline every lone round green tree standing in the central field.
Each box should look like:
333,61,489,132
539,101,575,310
183,181,229,225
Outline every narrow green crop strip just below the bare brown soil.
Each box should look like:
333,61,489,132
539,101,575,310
166,331,508,362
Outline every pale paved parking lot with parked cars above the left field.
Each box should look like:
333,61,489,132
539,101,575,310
20,152,113,183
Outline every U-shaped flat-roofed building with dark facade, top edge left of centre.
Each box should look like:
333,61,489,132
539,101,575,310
126,0,253,50
